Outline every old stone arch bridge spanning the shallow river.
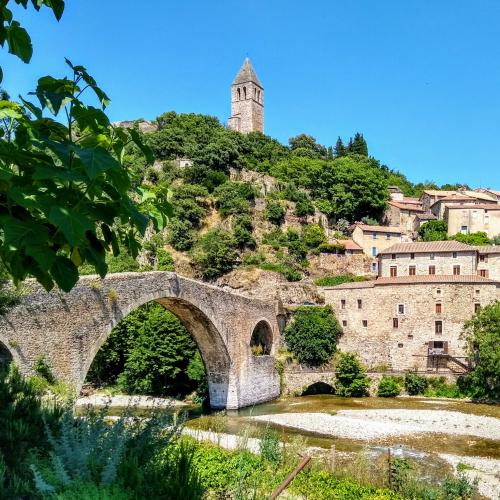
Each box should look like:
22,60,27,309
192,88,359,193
0,272,280,409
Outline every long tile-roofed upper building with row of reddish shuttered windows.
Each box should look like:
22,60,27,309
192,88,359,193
378,241,478,278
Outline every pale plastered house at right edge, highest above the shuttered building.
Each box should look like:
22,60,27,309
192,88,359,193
443,202,500,238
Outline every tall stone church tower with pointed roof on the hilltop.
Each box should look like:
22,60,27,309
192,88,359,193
228,57,264,134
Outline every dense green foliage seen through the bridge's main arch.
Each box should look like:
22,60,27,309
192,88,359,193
86,303,206,396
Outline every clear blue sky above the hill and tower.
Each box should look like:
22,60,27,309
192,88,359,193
0,0,500,188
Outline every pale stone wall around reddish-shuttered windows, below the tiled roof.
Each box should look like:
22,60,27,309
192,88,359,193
378,250,477,277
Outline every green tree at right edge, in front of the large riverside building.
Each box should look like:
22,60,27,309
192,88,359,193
464,302,500,401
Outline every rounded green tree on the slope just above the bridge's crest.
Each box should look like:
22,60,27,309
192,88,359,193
193,228,238,280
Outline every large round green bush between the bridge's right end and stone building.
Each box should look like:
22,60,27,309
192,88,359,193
285,306,340,366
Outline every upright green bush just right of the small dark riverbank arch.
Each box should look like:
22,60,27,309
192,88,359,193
335,352,370,397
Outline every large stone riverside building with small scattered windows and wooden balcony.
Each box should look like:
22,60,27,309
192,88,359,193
324,274,500,373
